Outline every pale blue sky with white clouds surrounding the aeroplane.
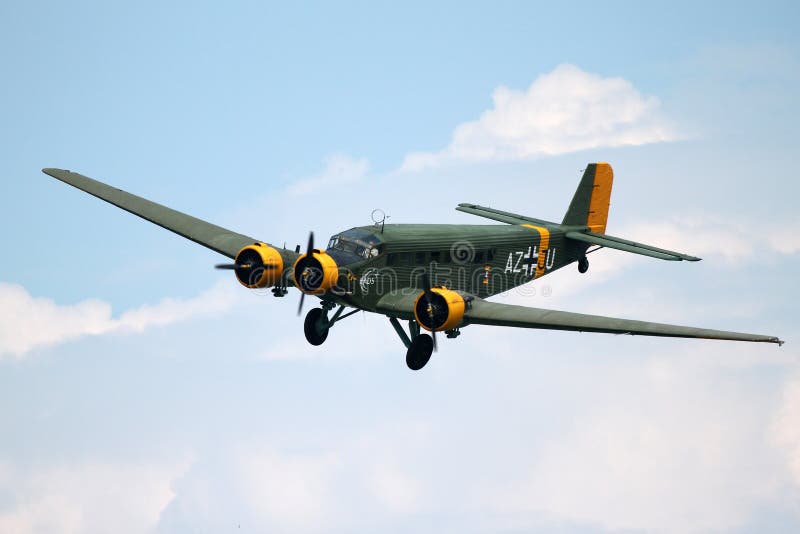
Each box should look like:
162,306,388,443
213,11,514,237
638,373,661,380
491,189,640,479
0,1,800,533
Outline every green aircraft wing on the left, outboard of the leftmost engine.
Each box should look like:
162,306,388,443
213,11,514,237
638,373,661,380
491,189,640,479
42,169,274,259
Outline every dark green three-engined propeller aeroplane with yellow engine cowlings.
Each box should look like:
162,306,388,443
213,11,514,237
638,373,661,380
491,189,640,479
44,163,783,370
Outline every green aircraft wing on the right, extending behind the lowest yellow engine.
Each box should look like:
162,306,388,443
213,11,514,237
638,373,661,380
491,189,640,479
378,291,783,345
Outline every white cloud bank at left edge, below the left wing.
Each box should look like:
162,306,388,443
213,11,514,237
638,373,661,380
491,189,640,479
0,281,234,358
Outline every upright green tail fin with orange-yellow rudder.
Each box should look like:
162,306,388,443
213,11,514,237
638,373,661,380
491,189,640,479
561,163,614,234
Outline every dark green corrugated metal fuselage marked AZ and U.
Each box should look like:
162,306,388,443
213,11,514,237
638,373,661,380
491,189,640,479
331,224,587,310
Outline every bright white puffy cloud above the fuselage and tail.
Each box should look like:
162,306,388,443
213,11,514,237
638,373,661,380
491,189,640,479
401,64,679,172
